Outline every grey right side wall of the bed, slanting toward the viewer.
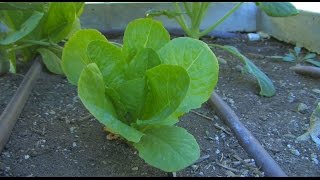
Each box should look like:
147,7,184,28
257,10,320,54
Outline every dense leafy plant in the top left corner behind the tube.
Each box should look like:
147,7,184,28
0,2,84,74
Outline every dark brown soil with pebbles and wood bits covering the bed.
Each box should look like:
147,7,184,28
0,34,320,176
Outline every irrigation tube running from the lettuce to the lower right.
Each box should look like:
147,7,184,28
209,92,287,177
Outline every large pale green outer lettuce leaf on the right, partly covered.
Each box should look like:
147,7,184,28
158,37,219,116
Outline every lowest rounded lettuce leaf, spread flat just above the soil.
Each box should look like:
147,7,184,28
134,126,200,172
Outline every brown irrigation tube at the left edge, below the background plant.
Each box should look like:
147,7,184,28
0,57,42,153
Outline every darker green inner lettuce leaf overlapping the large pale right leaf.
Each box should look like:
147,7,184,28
137,64,190,125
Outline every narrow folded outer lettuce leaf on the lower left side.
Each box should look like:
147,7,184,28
78,63,143,142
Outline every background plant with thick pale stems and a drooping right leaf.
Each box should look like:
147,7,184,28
146,2,298,97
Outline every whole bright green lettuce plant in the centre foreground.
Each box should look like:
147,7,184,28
62,18,218,172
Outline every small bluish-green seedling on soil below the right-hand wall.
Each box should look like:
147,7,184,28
268,46,320,67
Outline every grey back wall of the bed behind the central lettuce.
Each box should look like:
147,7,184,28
81,2,257,32
